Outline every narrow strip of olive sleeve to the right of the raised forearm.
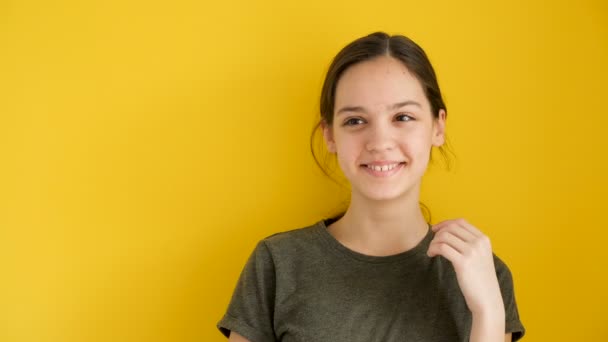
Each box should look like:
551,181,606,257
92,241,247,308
494,256,526,341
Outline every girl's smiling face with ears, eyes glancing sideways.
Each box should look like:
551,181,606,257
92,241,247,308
323,56,446,200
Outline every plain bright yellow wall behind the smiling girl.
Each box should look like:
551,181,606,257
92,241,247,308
0,0,608,342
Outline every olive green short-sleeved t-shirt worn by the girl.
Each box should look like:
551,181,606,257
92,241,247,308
217,221,525,342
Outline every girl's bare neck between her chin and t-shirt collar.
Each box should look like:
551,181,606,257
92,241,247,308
329,183,428,255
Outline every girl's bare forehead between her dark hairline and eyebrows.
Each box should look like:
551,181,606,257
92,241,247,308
334,56,428,109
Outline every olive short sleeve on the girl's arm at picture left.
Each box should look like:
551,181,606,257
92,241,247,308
217,241,276,342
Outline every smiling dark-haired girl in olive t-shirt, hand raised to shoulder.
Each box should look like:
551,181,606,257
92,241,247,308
218,32,525,342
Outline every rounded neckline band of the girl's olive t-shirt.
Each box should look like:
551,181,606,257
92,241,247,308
317,219,434,264
